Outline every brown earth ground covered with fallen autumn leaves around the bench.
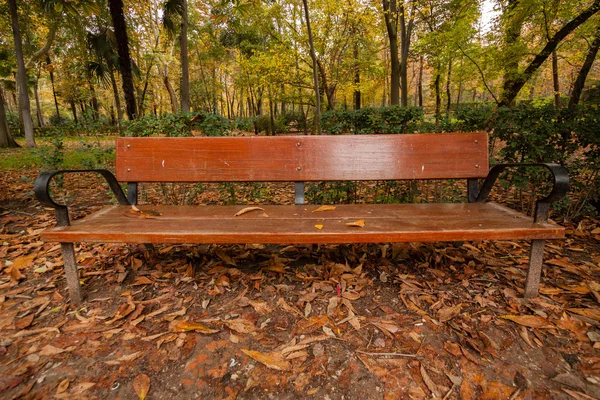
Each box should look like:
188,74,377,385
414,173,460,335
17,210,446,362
0,170,600,399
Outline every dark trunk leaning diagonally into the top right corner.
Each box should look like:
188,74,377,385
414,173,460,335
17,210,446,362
500,0,600,106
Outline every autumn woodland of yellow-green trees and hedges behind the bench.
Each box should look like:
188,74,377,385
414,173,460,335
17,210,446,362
0,0,600,218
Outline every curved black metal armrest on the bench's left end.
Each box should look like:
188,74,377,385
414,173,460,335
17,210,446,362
33,169,129,226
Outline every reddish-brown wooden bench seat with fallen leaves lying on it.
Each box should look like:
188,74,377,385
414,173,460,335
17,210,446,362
42,203,564,244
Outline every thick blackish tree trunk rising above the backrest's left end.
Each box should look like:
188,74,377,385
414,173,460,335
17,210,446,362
108,0,137,120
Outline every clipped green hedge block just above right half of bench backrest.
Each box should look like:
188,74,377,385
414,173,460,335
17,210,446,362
321,106,423,135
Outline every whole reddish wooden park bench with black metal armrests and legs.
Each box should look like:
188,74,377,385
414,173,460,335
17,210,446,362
35,133,569,304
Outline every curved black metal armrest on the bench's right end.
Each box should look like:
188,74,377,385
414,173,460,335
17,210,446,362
475,163,569,223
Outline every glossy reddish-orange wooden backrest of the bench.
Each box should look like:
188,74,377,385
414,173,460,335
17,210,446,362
117,132,488,182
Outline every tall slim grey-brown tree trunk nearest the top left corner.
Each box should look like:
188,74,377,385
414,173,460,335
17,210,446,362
8,0,36,147
